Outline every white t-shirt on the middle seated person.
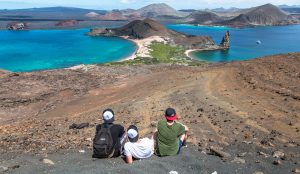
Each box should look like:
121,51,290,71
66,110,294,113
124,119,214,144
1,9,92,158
124,138,154,159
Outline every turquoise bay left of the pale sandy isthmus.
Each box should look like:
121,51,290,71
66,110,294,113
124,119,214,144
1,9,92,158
0,29,136,72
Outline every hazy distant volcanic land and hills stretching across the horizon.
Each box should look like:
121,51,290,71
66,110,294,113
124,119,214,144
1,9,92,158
0,3,300,29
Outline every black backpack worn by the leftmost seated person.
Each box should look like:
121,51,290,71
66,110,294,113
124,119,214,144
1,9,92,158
93,125,115,158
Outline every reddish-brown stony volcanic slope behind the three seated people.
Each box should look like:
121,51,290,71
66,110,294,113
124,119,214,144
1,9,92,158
0,53,300,173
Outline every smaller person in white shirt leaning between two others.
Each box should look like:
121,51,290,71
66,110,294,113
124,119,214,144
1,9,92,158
124,125,154,164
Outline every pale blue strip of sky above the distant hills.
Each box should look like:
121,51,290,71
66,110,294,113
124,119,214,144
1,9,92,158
0,0,300,10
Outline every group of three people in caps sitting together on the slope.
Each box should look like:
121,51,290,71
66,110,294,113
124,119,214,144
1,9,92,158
93,108,189,164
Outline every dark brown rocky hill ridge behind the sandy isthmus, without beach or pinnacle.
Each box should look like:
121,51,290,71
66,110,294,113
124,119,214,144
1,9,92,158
88,19,217,49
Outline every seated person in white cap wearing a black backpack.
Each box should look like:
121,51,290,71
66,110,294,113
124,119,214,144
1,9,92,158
93,109,126,158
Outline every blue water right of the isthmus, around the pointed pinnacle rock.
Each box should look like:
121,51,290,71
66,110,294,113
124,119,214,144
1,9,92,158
168,25,300,62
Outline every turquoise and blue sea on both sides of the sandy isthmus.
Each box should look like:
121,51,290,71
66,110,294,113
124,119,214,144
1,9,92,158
0,25,300,71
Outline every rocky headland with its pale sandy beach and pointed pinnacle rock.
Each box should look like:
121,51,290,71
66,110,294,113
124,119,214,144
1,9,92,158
87,18,230,63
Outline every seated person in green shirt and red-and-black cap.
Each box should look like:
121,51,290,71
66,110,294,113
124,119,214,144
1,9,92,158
156,108,189,156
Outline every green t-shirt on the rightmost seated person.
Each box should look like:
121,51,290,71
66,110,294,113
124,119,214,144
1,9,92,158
157,120,185,156
